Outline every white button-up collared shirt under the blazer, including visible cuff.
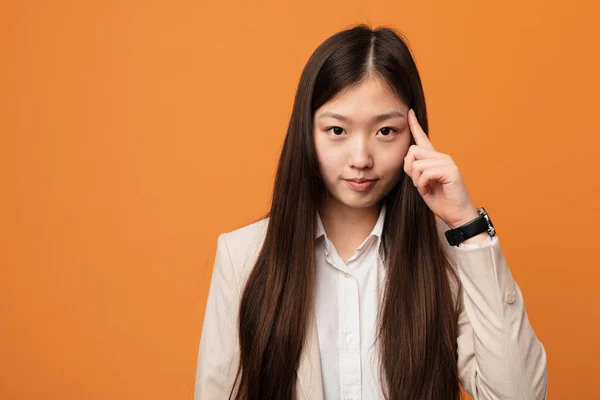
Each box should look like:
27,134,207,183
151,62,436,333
315,205,497,400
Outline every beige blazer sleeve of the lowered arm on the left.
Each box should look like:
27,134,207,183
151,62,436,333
194,234,240,400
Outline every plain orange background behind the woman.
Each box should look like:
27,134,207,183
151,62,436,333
0,0,600,400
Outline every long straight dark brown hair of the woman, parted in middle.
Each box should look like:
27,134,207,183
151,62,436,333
230,25,460,400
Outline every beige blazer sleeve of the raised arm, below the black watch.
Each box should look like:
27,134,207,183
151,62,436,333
448,236,548,400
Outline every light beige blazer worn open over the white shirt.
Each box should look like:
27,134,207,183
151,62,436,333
194,218,548,400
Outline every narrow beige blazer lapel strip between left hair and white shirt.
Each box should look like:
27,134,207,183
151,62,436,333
297,312,323,400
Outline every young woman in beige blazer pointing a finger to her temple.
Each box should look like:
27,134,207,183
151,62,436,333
195,25,547,400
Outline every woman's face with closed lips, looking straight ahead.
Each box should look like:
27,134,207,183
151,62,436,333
313,76,411,208
